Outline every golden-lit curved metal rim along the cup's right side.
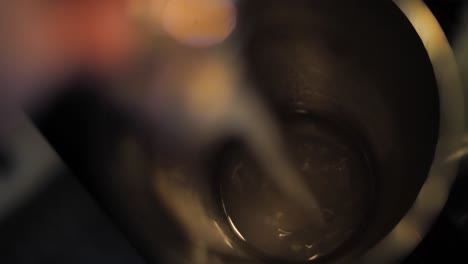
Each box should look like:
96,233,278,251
363,0,464,264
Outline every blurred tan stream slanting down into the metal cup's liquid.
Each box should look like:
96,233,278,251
230,91,324,227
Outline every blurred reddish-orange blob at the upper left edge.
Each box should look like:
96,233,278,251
51,0,136,68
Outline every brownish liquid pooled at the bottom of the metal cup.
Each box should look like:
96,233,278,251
214,111,376,263
